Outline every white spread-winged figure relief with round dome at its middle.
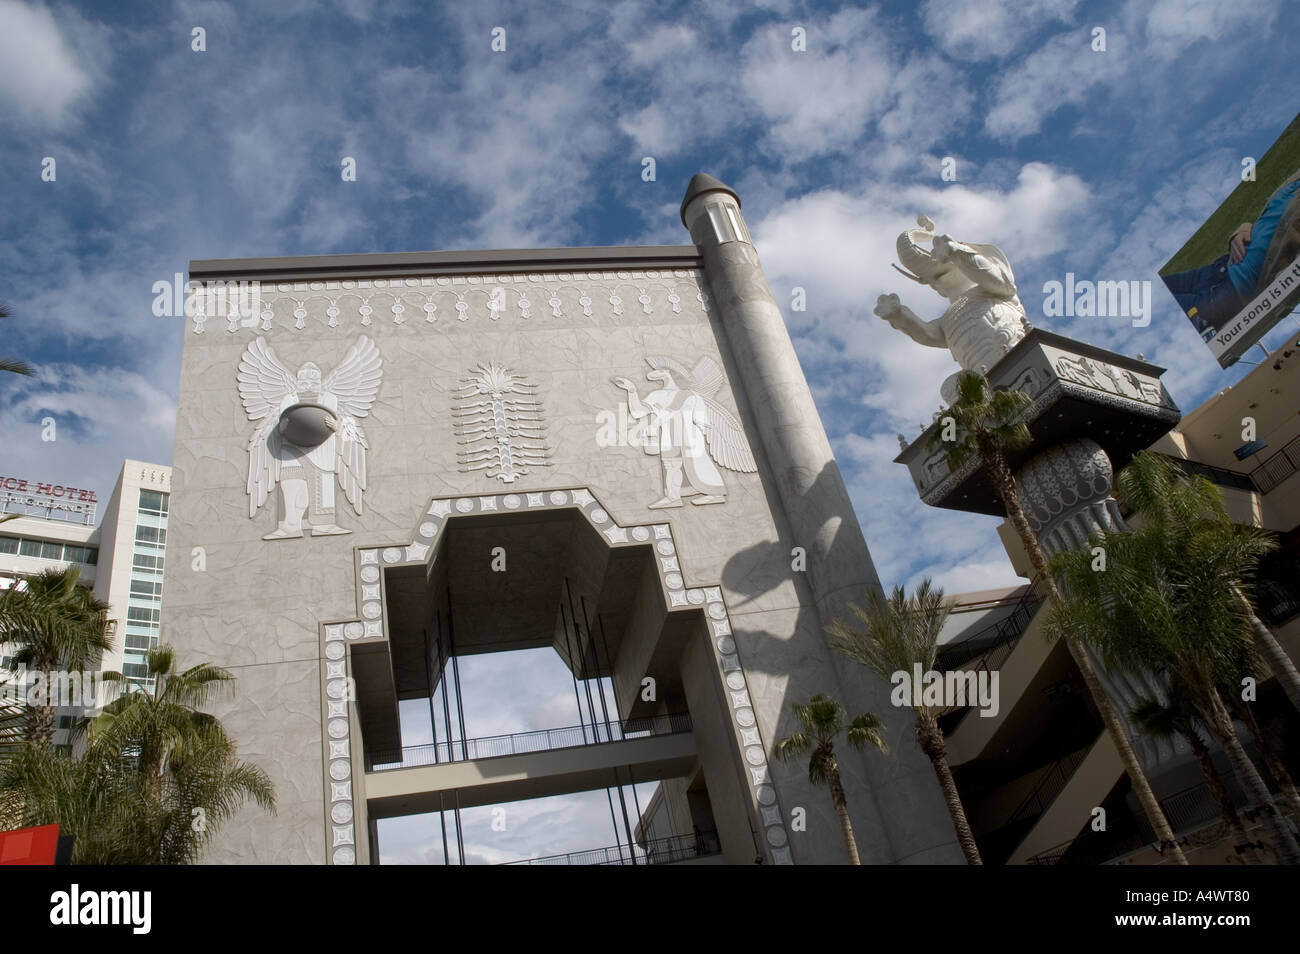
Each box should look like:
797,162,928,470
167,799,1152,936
239,335,384,539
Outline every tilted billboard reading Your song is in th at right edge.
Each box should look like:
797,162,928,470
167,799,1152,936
1160,116,1300,368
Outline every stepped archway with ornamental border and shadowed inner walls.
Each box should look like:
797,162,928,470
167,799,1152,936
320,489,792,864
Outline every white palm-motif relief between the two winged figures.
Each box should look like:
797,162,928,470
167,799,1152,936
451,363,551,483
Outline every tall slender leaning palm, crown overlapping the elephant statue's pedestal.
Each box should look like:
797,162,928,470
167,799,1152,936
945,372,1187,864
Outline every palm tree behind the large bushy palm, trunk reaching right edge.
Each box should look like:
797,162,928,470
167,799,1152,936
1115,451,1300,711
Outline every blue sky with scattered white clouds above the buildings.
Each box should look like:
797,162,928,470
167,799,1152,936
0,0,1300,868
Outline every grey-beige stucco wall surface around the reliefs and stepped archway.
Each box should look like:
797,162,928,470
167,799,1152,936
163,261,952,863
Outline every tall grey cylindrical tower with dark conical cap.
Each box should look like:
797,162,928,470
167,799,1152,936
681,173,961,863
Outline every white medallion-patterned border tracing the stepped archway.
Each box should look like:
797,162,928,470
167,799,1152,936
320,489,793,864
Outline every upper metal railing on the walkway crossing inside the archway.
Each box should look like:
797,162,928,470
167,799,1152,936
365,712,692,772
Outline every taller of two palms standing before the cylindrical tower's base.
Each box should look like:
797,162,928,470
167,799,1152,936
829,578,984,864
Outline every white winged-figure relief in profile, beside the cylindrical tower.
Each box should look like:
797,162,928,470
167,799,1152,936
614,355,758,509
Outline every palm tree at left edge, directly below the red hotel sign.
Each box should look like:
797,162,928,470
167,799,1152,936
0,567,113,745
